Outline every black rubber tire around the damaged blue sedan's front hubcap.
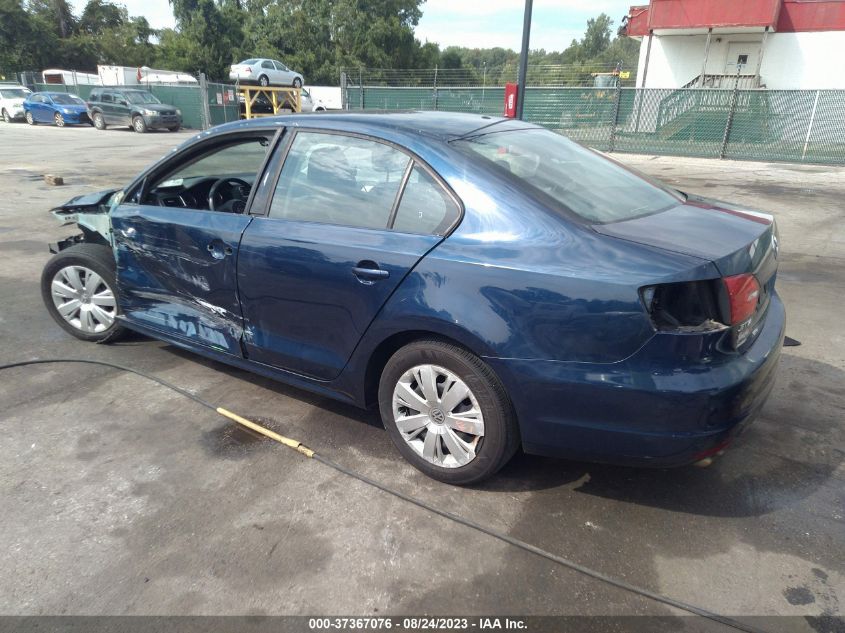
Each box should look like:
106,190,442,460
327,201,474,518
41,244,126,343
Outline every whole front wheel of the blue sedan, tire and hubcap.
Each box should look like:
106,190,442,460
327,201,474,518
41,244,124,343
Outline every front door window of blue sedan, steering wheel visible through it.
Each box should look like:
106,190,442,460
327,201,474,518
141,135,271,213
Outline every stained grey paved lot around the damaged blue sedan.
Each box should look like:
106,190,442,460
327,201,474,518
0,124,845,631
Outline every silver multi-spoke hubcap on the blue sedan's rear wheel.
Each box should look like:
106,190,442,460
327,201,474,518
393,365,484,468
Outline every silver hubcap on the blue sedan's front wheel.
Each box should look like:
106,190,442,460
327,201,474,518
50,266,117,334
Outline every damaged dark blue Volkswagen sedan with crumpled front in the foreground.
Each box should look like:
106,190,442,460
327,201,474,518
42,113,785,484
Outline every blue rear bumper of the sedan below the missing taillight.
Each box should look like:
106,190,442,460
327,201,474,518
486,294,786,467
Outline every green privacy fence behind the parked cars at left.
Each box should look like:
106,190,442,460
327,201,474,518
33,77,240,130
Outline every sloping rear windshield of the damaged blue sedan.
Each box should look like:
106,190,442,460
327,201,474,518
454,128,683,224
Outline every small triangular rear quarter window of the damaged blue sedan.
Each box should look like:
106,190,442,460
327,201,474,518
393,165,460,235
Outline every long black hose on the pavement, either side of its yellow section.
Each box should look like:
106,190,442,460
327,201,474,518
0,358,763,633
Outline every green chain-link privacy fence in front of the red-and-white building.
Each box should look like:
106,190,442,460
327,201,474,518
345,86,845,164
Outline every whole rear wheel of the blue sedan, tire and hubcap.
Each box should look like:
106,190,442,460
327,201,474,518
379,340,519,485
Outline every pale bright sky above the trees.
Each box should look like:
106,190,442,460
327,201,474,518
67,0,637,51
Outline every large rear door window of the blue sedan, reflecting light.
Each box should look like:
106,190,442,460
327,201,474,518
270,132,411,229
